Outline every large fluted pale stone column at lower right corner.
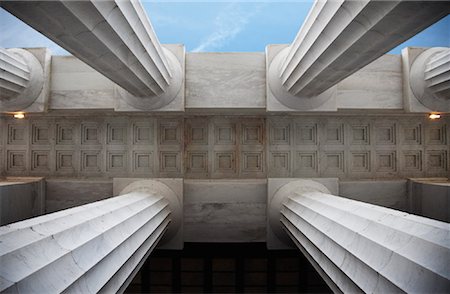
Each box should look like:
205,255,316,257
271,180,450,293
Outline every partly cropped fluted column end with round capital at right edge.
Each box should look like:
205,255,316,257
409,48,450,112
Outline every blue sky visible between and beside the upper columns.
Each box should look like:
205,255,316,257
0,1,450,55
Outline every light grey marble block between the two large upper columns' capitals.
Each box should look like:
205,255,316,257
186,53,265,113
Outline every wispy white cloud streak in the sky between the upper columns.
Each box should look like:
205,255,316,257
192,2,261,52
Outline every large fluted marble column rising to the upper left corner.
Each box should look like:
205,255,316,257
0,0,183,110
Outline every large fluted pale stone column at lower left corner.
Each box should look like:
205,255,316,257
0,180,181,293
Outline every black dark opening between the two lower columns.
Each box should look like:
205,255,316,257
125,243,332,293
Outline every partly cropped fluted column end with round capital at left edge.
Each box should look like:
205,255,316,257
0,48,44,112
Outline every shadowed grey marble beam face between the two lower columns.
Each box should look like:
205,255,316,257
184,180,267,243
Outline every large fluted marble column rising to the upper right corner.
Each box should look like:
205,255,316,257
268,0,449,110
